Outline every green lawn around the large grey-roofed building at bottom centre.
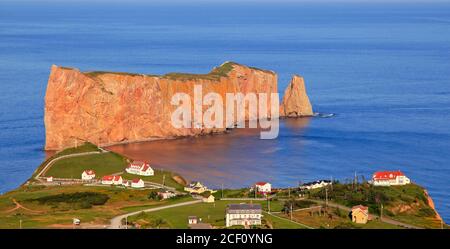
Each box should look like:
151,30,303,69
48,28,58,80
128,198,304,228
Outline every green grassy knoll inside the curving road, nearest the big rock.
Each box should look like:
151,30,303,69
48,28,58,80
45,152,127,179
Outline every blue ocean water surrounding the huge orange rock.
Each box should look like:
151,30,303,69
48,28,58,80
0,2,450,222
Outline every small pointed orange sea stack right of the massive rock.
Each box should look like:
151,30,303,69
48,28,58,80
280,75,313,117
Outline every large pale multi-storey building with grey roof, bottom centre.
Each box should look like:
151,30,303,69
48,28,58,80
225,204,262,227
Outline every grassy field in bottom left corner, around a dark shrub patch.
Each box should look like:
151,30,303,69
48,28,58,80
0,185,191,228
